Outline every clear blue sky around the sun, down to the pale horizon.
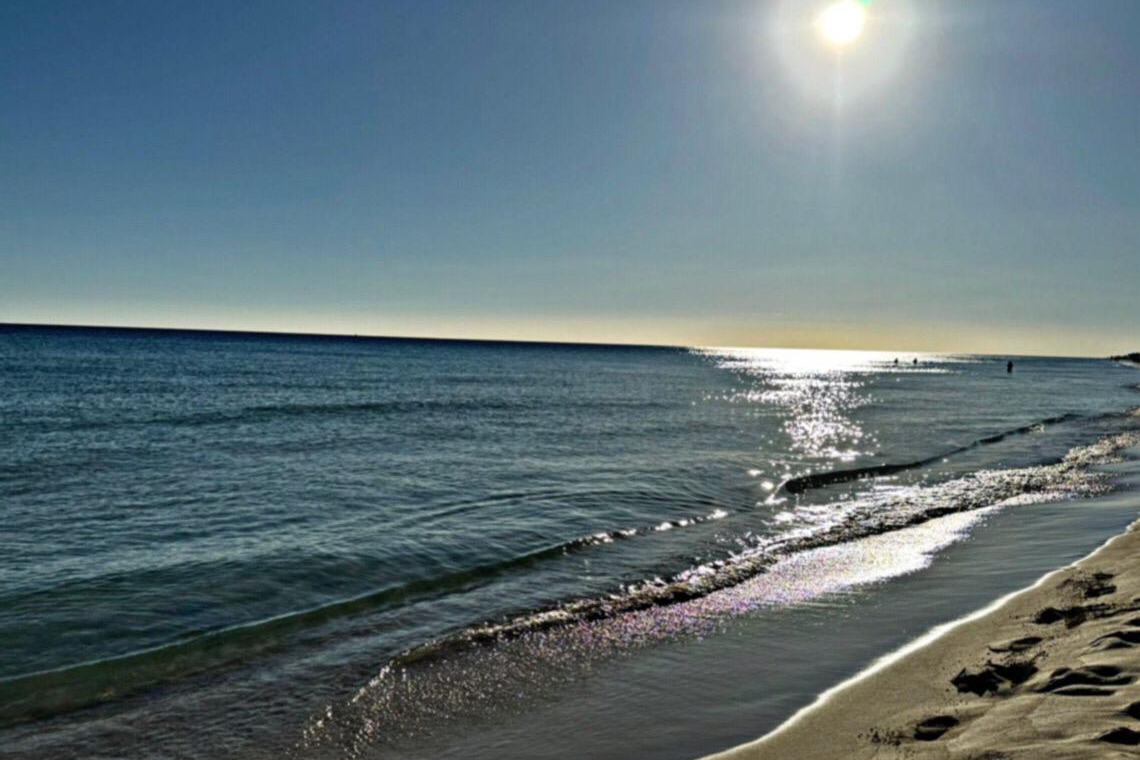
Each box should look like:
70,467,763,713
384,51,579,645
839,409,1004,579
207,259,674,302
0,0,1140,356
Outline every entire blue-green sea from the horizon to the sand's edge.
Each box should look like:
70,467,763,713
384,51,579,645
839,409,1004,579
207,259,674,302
0,327,1140,758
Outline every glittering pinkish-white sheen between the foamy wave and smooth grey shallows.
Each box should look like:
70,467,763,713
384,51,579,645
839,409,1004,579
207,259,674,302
298,510,985,755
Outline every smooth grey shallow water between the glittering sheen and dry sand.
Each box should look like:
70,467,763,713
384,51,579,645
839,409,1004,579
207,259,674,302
408,476,1140,760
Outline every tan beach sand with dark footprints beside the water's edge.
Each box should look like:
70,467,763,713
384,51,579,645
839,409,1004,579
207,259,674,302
709,522,1140,760
